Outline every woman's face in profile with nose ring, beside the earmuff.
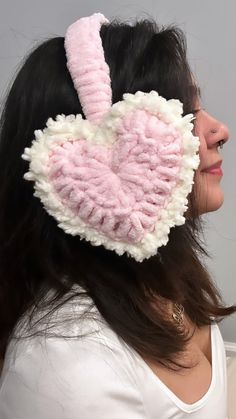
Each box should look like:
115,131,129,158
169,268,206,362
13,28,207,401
194,101,229,215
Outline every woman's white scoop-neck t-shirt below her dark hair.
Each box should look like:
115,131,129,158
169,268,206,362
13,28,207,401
0,288,227,419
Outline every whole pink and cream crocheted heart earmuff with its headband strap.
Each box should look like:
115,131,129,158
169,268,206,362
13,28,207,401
22,13,199,262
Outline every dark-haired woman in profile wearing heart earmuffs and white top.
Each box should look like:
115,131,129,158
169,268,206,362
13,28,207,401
0,14,236,419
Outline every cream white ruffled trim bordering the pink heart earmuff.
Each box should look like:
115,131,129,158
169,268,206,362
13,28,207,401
22,91,200,262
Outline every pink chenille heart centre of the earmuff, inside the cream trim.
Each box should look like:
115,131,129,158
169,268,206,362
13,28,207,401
49,109,182,243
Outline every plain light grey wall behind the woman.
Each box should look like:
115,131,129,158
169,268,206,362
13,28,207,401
0,0,236,343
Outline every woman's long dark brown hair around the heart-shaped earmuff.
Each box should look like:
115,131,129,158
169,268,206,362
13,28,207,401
0,20,236,367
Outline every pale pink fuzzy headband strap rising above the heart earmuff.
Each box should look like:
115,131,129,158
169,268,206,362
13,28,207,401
65,13,112,124
